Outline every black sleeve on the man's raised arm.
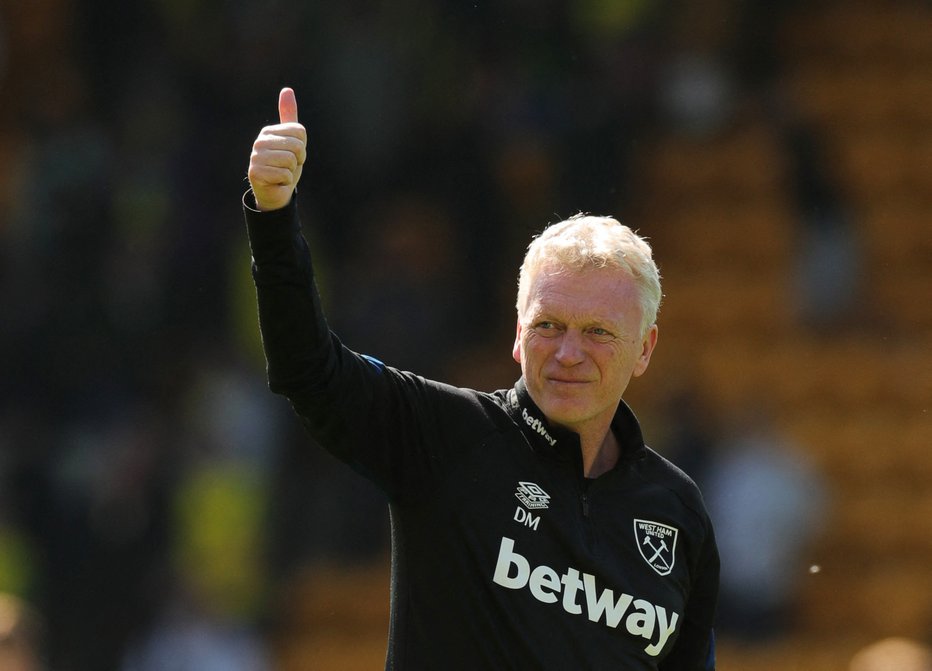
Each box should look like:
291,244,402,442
243,192,470,499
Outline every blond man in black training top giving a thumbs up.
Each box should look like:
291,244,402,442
244,89,718,671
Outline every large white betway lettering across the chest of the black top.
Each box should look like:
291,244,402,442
492,536,679,657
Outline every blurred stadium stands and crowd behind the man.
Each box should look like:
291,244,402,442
0,0,932,671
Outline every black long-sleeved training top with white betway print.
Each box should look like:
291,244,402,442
244,193,719,671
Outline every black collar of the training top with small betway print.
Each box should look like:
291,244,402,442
509,377,646,463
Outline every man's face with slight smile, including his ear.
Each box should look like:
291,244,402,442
513,267,657,433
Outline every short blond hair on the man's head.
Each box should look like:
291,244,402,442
516,214,663,336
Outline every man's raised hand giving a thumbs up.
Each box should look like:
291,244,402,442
248,88,307,212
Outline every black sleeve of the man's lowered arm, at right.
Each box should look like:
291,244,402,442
658,518,720,671
